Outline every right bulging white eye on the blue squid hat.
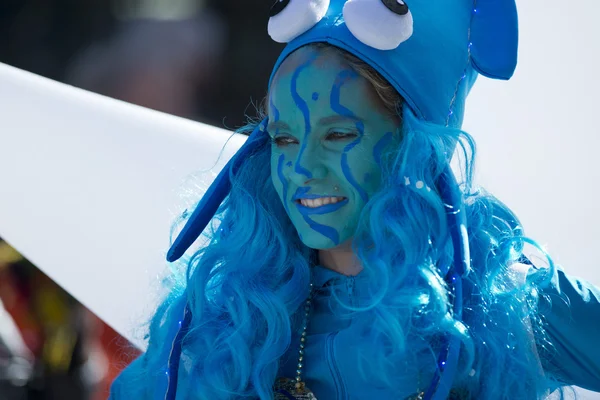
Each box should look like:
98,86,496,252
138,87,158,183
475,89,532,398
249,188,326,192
344,0,413,50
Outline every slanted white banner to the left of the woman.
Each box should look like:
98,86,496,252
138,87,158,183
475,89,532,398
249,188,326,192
0,64,245,348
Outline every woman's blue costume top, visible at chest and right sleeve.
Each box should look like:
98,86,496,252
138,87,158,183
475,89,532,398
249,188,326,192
110,266,600,400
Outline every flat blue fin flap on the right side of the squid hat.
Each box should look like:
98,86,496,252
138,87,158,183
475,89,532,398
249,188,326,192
470,0,519,80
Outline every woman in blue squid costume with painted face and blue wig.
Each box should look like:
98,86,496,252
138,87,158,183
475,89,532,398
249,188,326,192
112,0,600,400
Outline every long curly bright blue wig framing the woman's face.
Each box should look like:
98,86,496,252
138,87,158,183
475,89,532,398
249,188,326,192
112,68,553,400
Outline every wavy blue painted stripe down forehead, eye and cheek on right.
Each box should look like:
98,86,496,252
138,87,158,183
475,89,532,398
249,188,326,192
330,70,369,203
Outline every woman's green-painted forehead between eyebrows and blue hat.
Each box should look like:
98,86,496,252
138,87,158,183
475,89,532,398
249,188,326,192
269,48,377,111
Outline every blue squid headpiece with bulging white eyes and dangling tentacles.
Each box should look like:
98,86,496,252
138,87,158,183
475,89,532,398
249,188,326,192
166,0,518,399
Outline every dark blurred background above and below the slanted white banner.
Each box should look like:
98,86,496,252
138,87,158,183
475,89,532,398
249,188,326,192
0,0,280,400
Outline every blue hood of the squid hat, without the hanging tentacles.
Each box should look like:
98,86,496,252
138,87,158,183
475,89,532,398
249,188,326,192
271,0,518,128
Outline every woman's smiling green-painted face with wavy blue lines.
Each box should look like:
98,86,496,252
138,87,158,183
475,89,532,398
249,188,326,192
267,48,398,249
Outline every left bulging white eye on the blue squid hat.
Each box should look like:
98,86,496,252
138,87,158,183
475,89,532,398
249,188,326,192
269,0,330,43
